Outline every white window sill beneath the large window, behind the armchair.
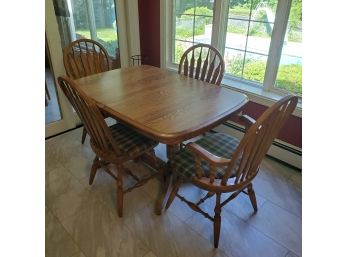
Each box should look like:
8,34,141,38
221,76,302,118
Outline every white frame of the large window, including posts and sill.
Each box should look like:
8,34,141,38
161,0,302,117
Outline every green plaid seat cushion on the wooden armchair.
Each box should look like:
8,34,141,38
173,133,239,181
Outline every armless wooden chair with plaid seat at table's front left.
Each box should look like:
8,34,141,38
58,77,162,217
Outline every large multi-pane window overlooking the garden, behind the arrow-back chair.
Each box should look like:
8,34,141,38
167,0,302,95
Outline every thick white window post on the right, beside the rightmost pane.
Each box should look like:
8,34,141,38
263,0,292,91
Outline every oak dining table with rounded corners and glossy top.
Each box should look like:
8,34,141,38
76,65,248,212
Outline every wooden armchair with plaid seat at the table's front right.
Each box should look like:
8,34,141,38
165,96,298,248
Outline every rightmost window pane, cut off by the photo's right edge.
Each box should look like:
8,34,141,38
275,0,302,95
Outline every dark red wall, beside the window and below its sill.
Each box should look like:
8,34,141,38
138,0,302,148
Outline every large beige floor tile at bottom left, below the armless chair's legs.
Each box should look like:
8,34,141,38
63,202,150,257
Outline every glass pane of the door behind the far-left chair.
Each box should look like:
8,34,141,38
53,0,121,68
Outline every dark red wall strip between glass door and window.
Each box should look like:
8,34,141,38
138,0,161,67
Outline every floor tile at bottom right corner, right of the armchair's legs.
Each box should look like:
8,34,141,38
248,202,302,255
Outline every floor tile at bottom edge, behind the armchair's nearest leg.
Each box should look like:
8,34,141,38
186,209,288,257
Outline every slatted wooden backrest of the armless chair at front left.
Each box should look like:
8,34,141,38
58,77,121,155
